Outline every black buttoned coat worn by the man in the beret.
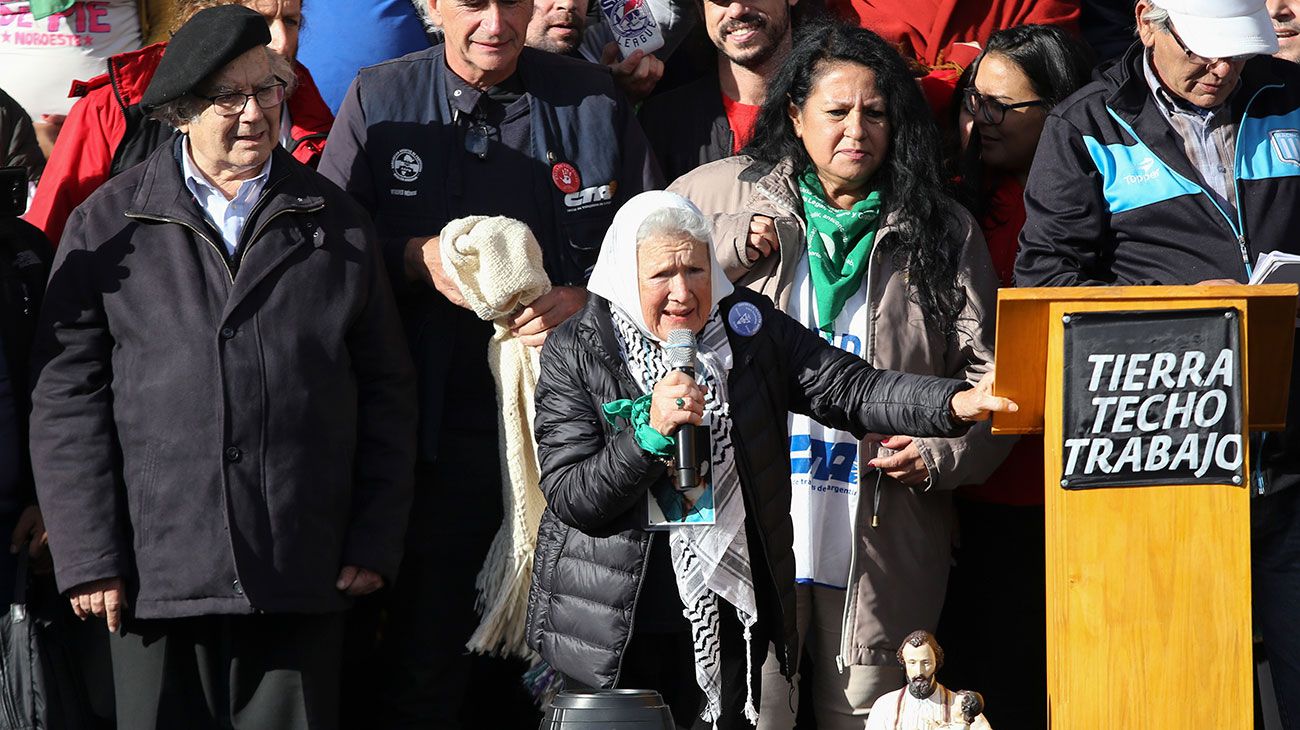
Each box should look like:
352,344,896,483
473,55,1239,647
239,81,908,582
31,140,415,618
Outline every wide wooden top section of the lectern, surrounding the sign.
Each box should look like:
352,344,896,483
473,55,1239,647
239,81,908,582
993,284,1300,434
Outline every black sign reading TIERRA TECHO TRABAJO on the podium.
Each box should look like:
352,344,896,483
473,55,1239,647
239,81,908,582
1061,303,1247,490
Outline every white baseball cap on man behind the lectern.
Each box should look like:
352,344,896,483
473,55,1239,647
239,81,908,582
1154,0,1278,58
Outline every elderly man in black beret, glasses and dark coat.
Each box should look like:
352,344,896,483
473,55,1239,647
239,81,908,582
31,5,415,730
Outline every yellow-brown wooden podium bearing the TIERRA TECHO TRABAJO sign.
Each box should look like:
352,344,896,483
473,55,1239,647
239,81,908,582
993,284,1296,730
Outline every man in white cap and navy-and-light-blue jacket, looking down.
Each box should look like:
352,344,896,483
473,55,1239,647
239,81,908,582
1015,0,1300,729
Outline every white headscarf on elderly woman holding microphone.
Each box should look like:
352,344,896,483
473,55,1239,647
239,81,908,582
586,190,733,342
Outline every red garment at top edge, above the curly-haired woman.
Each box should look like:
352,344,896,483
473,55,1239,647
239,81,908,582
827,0,1079,66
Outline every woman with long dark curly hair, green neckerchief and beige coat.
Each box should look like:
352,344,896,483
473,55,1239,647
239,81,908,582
670,23,1009,729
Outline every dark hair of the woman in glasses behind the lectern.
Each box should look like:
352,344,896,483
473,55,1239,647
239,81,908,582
952,23,1093,218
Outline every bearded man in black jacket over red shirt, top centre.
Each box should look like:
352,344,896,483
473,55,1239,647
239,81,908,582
641,0,798,182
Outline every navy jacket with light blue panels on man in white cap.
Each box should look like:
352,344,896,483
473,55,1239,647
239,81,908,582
1015,43,1300,492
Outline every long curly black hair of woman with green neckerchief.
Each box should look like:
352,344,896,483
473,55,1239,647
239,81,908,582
744,21,966,336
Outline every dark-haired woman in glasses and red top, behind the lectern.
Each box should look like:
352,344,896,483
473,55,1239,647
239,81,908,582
939,25,1089,727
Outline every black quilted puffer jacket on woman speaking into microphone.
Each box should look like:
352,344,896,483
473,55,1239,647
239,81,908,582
528,290,970,687
